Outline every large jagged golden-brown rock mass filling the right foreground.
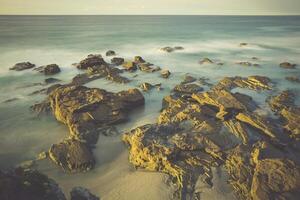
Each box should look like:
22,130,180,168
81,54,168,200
123,76,300,199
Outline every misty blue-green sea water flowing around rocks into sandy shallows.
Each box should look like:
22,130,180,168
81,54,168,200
0,16,300,200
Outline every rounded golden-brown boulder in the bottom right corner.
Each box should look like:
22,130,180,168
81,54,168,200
251,159,300,200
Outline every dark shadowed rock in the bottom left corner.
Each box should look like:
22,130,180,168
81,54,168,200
0,168,66,200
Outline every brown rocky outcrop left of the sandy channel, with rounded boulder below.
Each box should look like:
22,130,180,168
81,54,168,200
33,85,145,172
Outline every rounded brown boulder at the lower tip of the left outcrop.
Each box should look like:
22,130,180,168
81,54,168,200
49,139,95,172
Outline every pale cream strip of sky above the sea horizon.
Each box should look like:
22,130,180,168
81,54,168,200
0,0,300,15
